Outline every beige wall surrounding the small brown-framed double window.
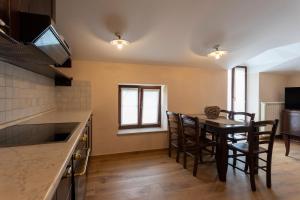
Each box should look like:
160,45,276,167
64,61,227,155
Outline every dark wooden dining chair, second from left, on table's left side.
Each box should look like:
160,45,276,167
180,115,215,176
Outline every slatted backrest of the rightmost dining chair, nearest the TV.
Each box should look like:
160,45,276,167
248,119,279,154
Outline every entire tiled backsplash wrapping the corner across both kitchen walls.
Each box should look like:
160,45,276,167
0,61,91,124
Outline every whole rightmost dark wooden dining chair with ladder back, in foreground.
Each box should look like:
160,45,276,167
228,119,278,191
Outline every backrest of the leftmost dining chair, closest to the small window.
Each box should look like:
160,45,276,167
166,111,181,139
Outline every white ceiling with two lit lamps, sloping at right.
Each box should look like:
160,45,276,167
56,0,300,71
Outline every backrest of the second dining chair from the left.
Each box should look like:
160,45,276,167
180,115,200,145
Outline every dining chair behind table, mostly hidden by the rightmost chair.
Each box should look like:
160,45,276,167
228,112,255,166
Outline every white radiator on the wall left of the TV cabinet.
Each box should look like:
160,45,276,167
260,102,284,134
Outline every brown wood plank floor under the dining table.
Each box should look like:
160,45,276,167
86,140,300,200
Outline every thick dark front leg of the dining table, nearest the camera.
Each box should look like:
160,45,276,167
216,132,228,182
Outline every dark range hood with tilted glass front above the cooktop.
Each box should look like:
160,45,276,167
19,12,71,65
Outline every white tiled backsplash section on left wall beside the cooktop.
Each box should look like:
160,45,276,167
0,62,56,123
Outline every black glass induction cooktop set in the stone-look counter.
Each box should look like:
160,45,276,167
0,122,79,147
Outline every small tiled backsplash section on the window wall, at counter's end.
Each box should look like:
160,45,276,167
56,80,91,110
